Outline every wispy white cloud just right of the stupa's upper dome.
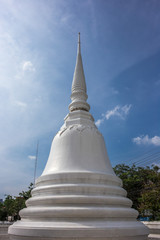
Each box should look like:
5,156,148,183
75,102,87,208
95,104,132,127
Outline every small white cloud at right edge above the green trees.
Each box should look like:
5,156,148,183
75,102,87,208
132,135,160,146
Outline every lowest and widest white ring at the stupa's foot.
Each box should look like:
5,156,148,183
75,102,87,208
9,220,148,240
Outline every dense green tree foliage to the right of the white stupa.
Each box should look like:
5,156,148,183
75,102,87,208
114,164,160,220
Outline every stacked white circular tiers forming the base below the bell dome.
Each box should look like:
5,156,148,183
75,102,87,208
9,172,148,240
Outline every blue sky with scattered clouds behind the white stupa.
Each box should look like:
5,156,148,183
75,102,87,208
0,0,160,198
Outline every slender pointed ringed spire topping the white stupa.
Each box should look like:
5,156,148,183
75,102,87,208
69,33,90,112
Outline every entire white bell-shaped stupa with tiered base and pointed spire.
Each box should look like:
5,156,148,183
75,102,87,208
9,34,148,240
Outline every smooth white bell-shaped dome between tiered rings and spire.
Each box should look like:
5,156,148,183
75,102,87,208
42,110,114,176
